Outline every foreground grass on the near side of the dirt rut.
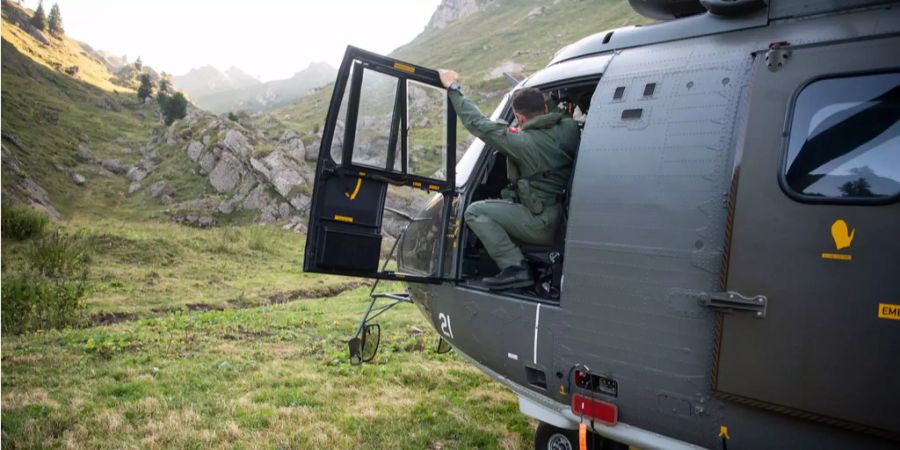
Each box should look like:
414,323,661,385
2,289,532,449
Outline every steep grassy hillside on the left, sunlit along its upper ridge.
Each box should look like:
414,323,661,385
2,1,212,220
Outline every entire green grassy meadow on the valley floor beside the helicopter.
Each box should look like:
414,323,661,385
2,216,533,449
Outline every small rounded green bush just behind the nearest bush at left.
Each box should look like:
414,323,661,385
25,231,90,278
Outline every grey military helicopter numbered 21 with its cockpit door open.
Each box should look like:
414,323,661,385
304,0,900,449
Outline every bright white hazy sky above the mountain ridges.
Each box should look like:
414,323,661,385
36,0,439,81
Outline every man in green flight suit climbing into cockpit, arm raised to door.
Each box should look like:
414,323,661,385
439,69,581,289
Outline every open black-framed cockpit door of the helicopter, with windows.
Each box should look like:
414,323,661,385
303,47,456,283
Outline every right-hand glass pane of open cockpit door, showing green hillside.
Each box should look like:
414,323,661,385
406,81,447,180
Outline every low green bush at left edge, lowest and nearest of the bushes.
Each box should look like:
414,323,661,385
0,272,85,335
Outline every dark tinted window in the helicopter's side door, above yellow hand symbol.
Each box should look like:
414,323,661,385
783,72,900,203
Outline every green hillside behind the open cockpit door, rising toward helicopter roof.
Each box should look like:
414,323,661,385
255,0,649,153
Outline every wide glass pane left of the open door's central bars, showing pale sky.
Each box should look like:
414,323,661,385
353,69,399,169
